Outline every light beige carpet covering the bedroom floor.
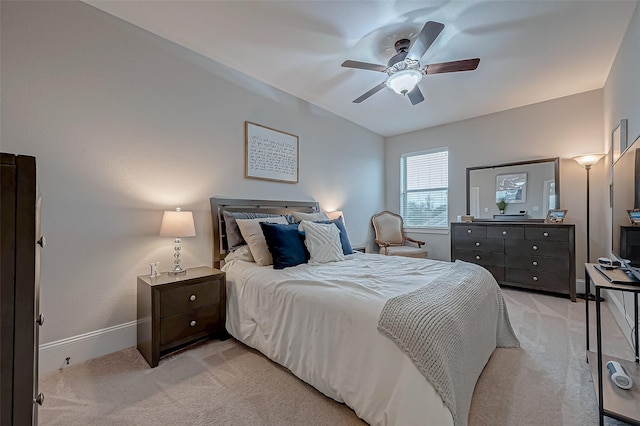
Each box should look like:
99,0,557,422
39,289,633,426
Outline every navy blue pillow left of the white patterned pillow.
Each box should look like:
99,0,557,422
260,222,309,269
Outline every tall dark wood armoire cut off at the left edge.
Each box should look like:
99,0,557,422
0,153,44,426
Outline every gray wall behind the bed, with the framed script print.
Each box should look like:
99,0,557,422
0,1,384,343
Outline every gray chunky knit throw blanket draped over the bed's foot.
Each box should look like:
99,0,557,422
378,261,520,426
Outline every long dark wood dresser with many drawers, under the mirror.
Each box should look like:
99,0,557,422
451,222,576,302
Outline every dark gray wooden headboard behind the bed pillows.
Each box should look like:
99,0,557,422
210,197,320,268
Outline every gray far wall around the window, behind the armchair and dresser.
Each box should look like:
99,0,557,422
385,90,608,262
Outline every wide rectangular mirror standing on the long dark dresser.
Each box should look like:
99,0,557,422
467,157,560,222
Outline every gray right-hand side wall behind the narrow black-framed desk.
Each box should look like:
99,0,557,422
603,1,640,339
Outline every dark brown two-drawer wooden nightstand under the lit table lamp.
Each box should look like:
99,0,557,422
137,266,226,367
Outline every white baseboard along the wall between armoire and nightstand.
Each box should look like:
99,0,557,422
38,321,137,375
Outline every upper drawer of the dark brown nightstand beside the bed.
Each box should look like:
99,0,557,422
160,281,220,318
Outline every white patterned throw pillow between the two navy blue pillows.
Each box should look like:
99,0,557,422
300,220,345,264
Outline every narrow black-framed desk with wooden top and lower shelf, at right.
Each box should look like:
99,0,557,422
584,263,640,425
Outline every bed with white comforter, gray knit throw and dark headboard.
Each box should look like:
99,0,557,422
211,197,519,426
